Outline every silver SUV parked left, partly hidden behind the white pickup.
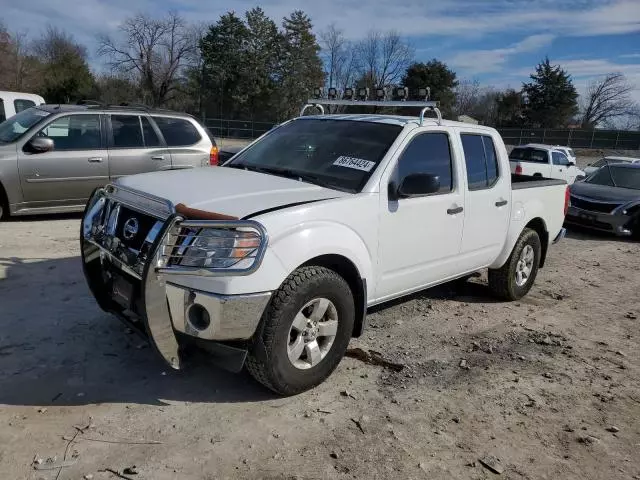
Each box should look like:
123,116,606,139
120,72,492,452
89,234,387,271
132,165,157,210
0,105,218,219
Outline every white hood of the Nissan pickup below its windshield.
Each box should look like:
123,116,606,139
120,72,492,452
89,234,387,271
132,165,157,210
116,167,350,218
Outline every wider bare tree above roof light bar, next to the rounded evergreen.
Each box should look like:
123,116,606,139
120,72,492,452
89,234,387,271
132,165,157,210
356,30,413,87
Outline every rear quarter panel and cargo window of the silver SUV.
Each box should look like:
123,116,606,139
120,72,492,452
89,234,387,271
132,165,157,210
152,115,212,169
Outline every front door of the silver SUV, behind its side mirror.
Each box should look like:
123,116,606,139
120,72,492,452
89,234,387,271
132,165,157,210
18,113,109,207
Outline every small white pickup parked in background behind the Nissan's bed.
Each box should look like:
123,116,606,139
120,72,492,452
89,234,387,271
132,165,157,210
509,143,585,184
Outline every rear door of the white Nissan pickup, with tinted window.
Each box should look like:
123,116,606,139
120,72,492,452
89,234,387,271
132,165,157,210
460,130,511,269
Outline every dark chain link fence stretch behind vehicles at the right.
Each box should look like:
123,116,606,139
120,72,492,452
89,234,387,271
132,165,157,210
498,128,640,150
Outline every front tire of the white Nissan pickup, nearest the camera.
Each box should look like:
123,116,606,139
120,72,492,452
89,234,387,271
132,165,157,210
246,266,355,395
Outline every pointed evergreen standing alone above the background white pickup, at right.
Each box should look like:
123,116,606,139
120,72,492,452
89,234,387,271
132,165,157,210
522,58,578,128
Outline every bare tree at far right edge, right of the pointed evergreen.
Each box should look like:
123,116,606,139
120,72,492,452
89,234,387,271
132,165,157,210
581,73,637,128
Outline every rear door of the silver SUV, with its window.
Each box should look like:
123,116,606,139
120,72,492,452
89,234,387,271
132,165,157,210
108,113,171,179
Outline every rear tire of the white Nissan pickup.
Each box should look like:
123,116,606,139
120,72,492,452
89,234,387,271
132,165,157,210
489,228,542,300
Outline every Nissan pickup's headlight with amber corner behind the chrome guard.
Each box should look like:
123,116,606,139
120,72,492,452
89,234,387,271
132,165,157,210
174,228,261,268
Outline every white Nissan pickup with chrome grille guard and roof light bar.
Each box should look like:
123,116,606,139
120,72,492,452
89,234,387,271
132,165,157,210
81,100,568,395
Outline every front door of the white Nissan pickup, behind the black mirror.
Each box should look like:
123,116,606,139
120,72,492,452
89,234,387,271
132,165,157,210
376,130,466,301
